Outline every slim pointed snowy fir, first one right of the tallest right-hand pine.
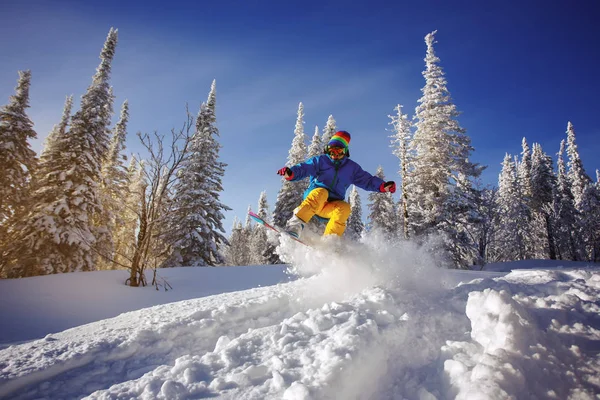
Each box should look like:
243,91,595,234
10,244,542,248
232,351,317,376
498,153,526,261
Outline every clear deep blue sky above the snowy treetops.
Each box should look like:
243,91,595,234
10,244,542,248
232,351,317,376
0,0,600,230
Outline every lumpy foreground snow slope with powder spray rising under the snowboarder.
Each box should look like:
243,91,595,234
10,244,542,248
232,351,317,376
0,236,600,399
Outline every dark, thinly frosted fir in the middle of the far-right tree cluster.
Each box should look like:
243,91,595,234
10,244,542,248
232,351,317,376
529,143,556,260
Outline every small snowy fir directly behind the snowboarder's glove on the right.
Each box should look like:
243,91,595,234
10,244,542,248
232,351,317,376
367,165,398,240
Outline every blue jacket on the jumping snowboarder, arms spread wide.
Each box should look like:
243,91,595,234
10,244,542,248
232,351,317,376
290,154,384,200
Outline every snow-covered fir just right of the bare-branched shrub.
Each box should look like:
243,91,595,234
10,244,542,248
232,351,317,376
165,81,231,266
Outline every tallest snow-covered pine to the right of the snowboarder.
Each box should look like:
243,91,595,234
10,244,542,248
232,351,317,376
406,31,483,241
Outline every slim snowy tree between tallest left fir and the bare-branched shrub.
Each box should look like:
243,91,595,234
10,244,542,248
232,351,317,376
96,100,129,269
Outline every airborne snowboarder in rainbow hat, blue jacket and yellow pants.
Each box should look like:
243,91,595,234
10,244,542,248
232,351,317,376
277,131,396,238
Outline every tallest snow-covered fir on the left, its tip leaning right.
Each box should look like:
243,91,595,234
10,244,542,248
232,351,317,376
3,28,117,276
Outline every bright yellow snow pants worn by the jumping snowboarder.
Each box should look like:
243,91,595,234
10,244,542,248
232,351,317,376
294,188,350,236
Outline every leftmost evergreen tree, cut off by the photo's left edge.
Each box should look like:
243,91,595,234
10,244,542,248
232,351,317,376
0,71,37,238
